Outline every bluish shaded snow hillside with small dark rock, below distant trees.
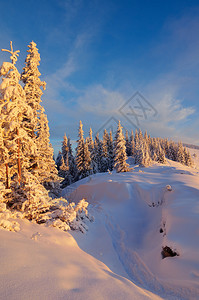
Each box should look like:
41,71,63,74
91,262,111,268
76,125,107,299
62,156,199,299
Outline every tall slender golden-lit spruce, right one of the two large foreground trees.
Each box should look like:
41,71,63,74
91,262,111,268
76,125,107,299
21,42,59,192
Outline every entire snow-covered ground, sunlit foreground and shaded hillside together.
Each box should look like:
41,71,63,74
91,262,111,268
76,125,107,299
0,149,199,300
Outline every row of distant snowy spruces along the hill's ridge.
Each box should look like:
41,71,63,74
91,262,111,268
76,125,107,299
56,121,193,187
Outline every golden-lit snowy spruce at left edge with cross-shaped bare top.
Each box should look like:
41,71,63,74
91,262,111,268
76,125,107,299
0,42,36,188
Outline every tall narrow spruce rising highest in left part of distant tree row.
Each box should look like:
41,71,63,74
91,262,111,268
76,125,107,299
75,121,92,179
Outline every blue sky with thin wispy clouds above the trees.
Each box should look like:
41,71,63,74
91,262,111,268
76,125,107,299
0,0,199,155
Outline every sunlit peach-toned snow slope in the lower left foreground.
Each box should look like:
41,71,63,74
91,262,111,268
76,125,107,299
0,220,159,300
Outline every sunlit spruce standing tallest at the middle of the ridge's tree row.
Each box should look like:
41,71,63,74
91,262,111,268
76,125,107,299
114,121,129,173
